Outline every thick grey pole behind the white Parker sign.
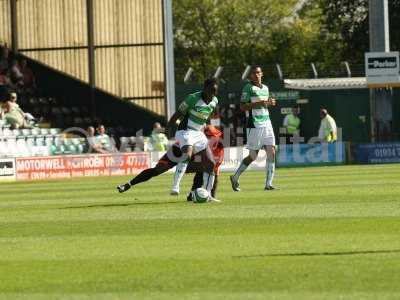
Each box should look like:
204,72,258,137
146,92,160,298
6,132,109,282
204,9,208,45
369,0,390,142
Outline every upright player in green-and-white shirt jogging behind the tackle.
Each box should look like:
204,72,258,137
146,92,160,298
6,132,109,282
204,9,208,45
230,66,276,192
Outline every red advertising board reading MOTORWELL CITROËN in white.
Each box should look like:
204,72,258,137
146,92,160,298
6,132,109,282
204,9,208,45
15,152,150,180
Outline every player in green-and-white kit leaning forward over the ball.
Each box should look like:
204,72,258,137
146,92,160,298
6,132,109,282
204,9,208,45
168,79,218,195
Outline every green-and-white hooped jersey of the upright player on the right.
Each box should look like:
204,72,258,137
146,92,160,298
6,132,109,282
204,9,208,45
241,82,270,128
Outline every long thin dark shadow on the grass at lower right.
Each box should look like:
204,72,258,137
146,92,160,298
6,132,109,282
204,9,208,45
234,249,400,258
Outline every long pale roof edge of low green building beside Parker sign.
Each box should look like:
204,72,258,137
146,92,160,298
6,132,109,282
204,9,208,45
285,77,368,90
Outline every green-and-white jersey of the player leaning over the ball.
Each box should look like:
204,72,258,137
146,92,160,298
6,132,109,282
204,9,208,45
178,92,218,130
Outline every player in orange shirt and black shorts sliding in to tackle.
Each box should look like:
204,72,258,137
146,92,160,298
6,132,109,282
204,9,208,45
117,125,224,201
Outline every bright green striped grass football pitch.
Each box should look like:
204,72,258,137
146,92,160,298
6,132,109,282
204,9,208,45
0,165,400,300
